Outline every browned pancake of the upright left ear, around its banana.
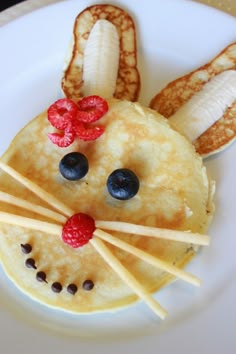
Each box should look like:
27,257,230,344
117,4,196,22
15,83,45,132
61,4,140,101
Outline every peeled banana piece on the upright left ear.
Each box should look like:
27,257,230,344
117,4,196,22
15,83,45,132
83,20,120,99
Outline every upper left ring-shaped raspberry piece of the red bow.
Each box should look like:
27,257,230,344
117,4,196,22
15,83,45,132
48,98,78,130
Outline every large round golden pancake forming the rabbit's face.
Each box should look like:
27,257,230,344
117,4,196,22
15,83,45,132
0,100,212,313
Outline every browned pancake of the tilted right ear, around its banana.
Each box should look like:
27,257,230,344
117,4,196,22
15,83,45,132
150,43,236,156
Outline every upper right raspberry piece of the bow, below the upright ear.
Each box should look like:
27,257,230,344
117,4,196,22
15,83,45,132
77,95,108,123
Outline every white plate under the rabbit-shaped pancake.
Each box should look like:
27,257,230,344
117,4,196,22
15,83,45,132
0,0,236,354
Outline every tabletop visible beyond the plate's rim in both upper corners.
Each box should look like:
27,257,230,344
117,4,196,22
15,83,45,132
0,0,236,26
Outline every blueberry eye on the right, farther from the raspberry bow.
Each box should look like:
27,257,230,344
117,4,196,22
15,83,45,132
107,168,139,200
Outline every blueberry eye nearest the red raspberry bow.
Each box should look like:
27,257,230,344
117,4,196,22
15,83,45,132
59,152,89,181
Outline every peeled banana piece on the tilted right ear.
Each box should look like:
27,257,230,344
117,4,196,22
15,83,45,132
169,70,236,142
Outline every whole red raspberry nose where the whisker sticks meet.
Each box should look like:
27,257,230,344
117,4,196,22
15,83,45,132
62,213,95,248
